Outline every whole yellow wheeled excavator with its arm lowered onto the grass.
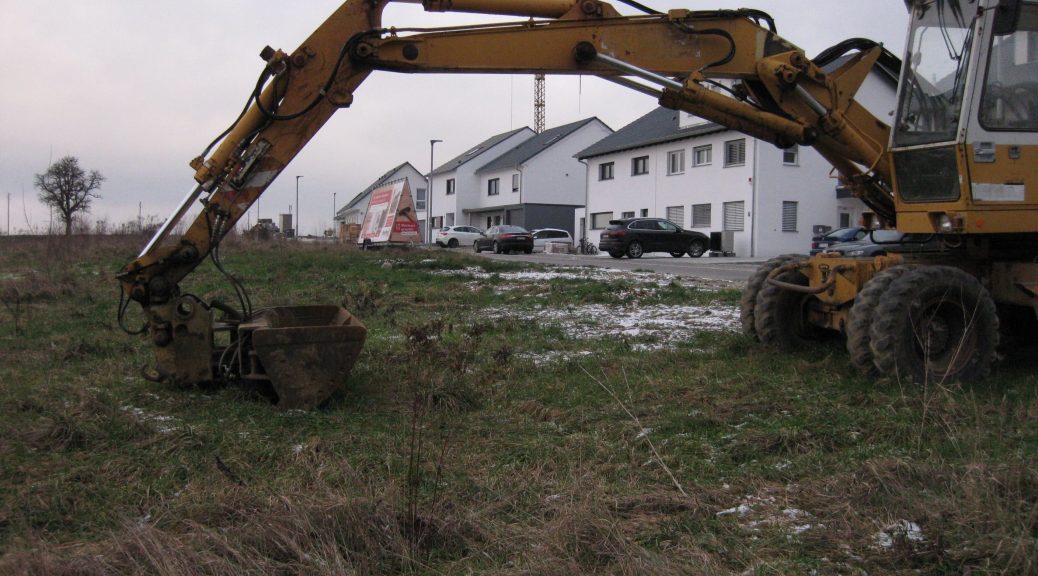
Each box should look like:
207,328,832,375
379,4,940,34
118,0,1038,408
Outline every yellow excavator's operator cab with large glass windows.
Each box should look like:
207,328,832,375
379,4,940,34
891,0,1038,236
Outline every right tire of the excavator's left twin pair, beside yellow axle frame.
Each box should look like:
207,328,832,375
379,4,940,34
754,270,818,350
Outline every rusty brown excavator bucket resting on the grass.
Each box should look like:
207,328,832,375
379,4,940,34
239,306,367,410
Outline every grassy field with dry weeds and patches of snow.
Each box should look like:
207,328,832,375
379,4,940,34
0,238,1038,575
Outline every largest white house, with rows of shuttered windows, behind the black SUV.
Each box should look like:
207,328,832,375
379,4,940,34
575,58,897,257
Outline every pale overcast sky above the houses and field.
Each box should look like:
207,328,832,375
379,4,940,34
0,0,907,234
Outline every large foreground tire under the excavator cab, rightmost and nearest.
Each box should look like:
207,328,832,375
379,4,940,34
869,266,999,384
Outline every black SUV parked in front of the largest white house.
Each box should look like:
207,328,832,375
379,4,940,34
598,218,710,258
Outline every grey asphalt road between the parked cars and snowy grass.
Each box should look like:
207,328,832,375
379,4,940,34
469,248,764,281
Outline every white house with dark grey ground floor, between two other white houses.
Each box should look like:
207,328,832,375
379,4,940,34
467,117,612,232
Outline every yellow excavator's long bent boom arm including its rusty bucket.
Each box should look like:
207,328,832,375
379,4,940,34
118,0,894,406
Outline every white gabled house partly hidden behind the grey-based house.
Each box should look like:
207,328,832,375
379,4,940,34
429,127,536,236
